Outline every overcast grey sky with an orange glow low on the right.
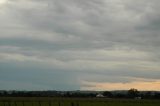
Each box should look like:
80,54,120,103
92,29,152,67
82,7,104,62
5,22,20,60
0,0,160,90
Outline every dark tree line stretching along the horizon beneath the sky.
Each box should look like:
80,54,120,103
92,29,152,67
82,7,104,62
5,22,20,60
0,88,160,99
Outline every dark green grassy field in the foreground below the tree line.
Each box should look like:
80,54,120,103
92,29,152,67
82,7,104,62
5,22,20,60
0,97,160,106
